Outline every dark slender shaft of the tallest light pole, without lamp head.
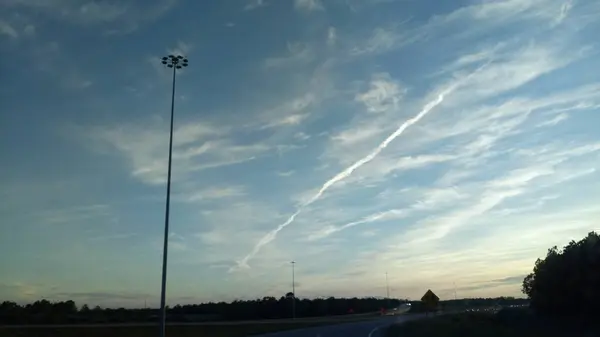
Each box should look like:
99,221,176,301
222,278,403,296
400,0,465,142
160,65,177,337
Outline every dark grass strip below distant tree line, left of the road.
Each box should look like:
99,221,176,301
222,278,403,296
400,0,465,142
0,322,332,337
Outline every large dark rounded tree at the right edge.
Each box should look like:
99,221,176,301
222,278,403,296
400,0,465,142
522,232,600,319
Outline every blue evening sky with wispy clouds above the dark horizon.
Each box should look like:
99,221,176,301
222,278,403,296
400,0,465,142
0,0,600,307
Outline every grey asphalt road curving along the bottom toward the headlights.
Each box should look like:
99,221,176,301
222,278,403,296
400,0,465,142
251,315,425,337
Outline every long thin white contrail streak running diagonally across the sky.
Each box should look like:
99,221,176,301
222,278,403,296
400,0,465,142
230,66,491,271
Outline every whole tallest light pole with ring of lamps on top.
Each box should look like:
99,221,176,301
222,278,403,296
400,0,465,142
160,55,188,337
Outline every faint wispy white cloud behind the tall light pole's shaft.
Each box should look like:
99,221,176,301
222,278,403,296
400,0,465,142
87,122,270,184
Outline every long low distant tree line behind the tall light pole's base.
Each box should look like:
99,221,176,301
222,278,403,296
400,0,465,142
0,293,404,325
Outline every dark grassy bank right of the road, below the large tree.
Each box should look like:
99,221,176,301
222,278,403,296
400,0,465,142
386,310,600,337
